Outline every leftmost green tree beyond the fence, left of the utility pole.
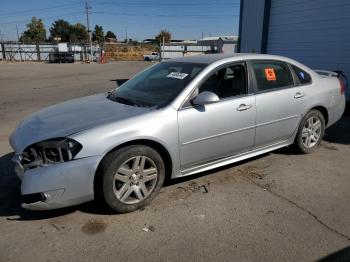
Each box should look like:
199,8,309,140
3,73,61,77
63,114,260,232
22,16,46,43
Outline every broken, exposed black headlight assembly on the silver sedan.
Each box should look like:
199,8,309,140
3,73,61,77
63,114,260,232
21,137,82,169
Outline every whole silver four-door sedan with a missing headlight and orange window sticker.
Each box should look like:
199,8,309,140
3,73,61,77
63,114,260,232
10,54,345,212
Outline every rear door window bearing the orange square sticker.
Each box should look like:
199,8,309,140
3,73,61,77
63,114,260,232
252,61,293,91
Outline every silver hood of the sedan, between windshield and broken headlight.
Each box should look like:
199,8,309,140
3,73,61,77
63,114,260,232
10,94,152,152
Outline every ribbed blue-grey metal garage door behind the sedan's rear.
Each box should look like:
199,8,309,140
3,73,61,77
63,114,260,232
267,0,350,94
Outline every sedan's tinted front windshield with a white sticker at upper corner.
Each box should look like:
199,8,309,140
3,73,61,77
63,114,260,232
109,62,206,107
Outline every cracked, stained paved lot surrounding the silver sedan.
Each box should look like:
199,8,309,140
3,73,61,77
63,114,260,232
0,62,350,261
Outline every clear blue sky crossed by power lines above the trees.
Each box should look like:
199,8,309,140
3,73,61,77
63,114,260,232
0,0,240,40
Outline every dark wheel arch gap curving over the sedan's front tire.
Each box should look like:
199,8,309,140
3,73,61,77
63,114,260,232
93,139,173,197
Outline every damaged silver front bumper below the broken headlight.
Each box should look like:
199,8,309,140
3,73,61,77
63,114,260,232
13,156,101,210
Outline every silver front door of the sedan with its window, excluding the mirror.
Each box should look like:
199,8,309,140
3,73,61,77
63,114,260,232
178,64,256,170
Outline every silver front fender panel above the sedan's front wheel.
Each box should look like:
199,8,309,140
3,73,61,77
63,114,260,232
70,105,180,175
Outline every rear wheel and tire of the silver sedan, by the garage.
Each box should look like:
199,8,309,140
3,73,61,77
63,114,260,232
294,110,325,154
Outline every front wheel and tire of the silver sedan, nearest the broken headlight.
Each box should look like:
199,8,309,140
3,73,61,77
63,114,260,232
102,145,165,213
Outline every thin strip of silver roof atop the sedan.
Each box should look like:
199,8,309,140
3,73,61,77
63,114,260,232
163,53,287,64
